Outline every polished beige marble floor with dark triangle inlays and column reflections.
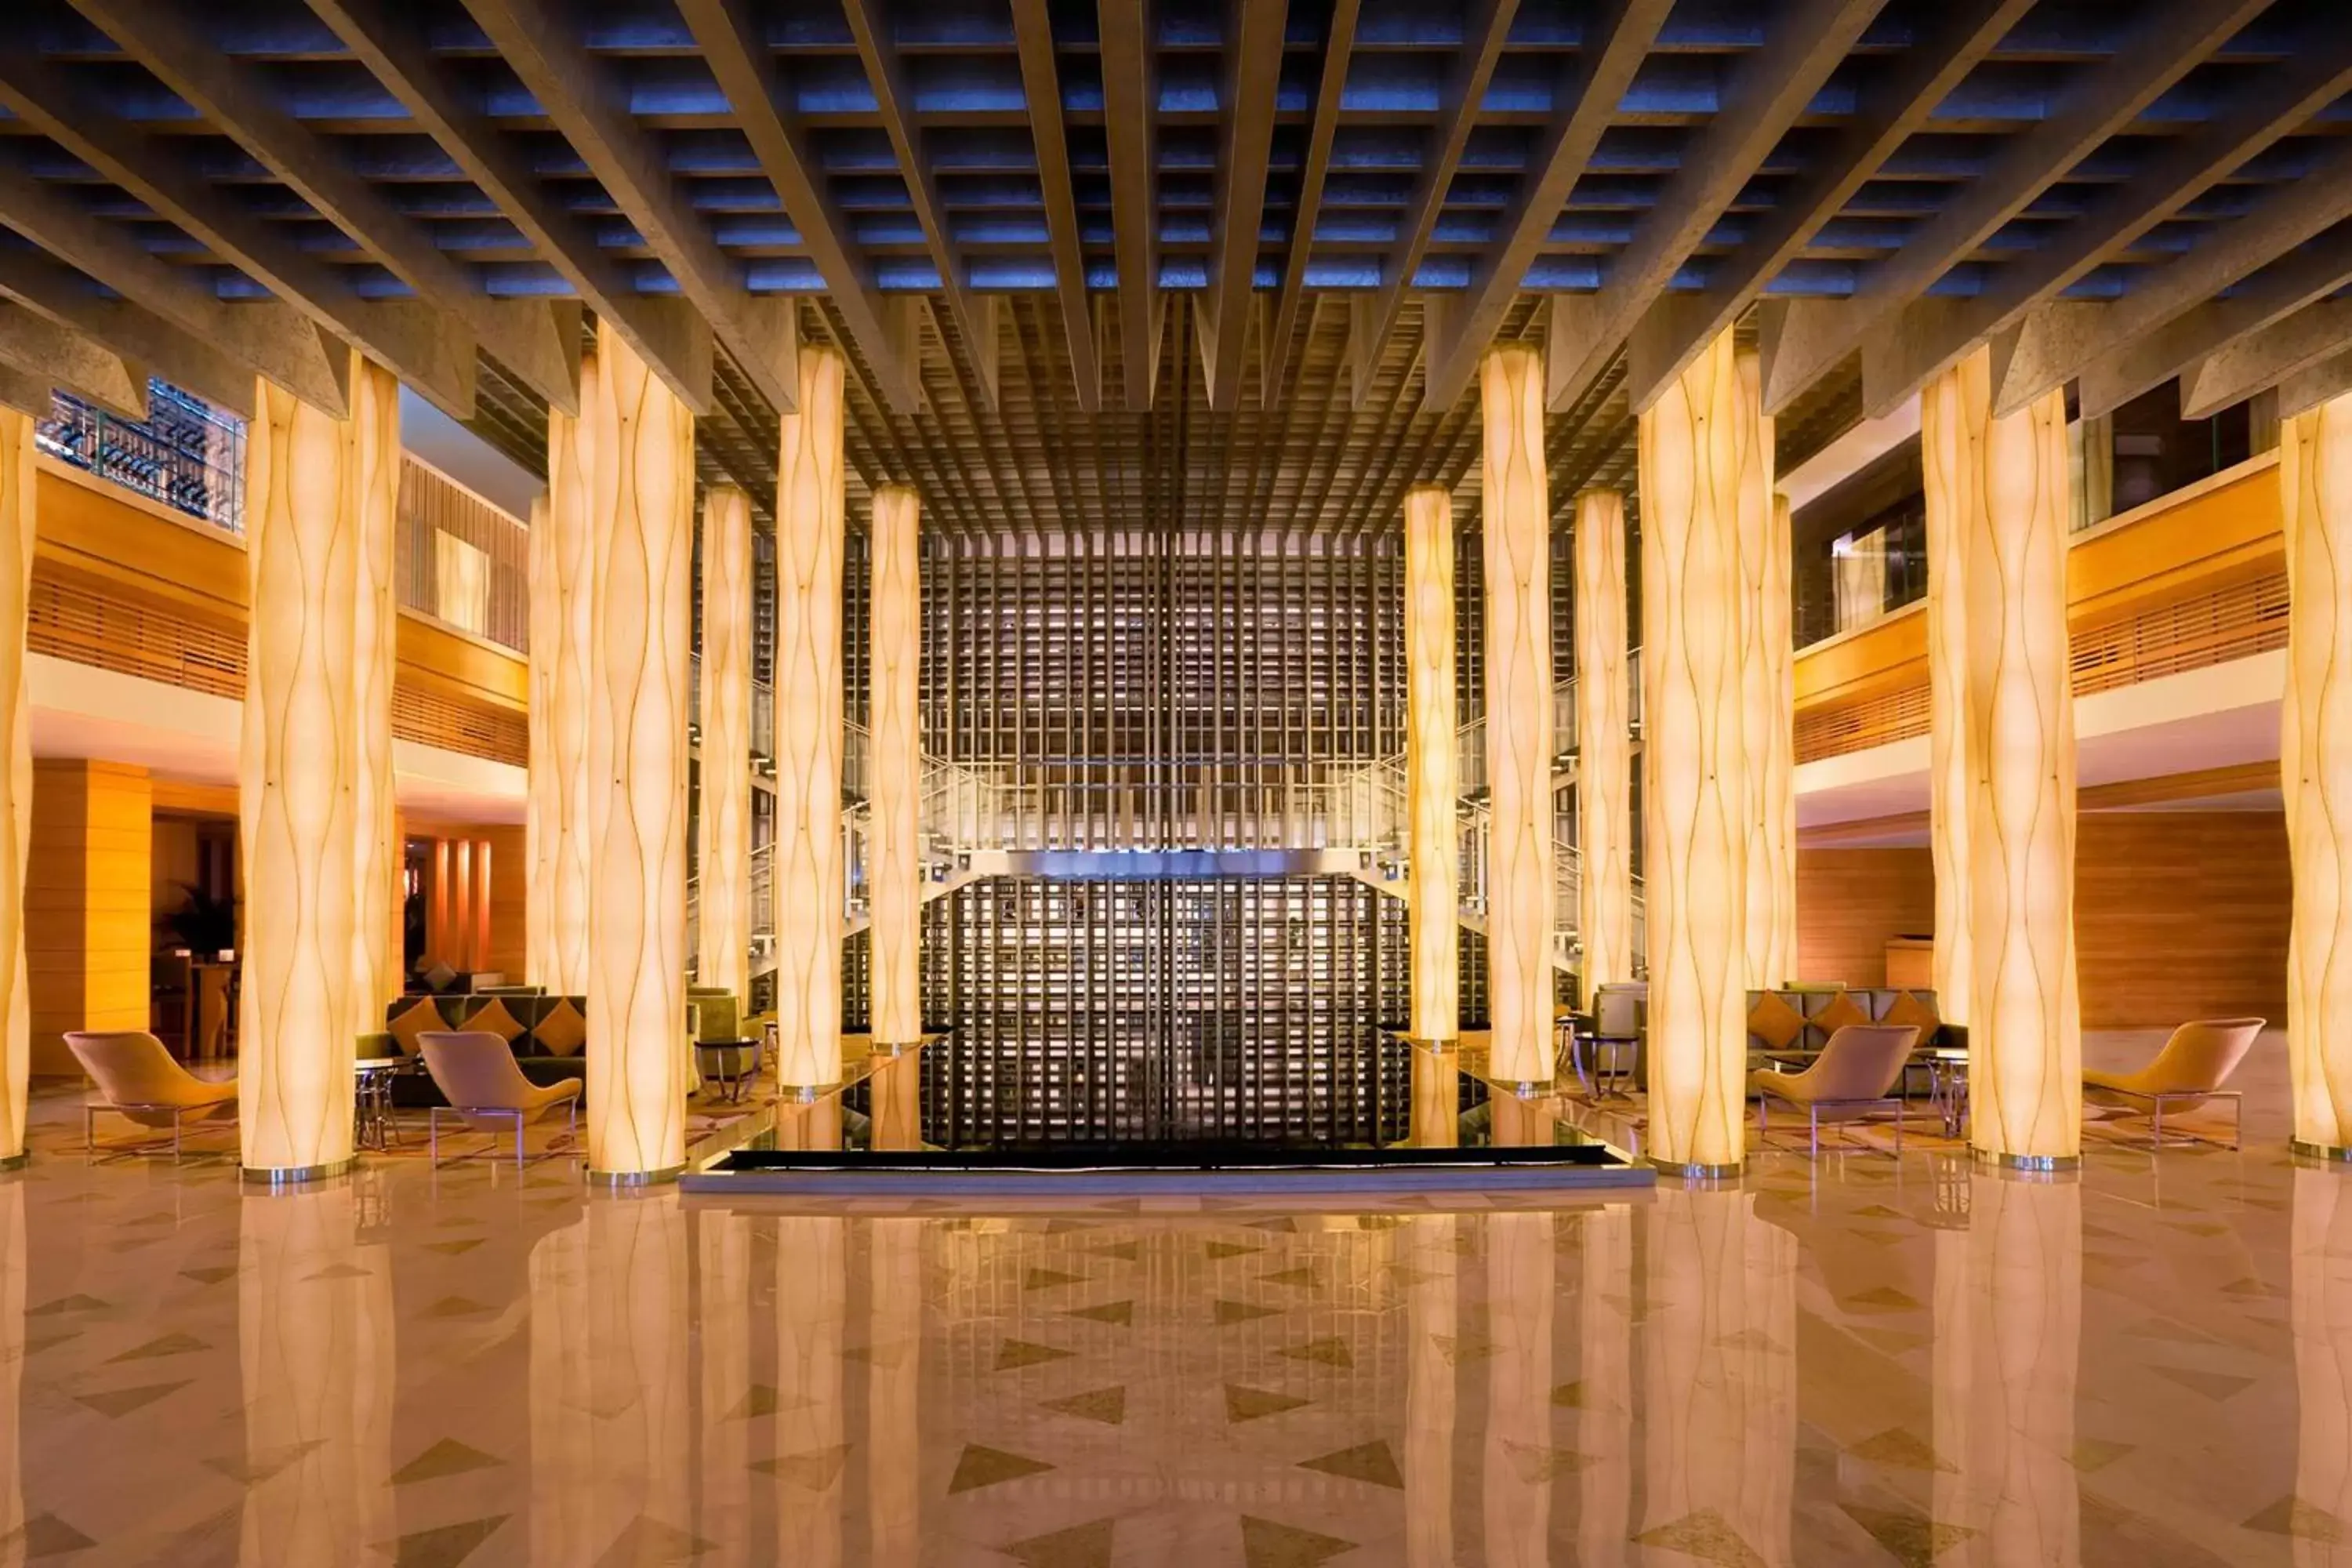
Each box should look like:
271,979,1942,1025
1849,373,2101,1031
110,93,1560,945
0,1036,2352,1568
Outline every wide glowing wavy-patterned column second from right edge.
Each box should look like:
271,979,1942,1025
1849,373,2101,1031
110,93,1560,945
1959,348,2082,1161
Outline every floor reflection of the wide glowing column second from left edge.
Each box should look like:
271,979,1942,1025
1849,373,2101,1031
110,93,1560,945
236,1182,395,1568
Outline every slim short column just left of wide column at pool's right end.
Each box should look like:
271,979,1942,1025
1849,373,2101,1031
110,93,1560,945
1573,489,1632,1001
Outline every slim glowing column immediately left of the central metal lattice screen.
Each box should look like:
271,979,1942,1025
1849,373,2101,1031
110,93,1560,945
866,485,922,1046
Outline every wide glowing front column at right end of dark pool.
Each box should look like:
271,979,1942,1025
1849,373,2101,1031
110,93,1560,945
1639,332,1748,1171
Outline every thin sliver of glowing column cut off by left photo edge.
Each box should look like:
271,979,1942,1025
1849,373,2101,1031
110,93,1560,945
0,409,38,1166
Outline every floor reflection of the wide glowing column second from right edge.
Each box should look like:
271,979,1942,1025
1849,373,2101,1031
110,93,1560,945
1933,1171,2082,1568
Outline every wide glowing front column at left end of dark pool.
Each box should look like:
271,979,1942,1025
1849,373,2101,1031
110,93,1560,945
583,325,694,1180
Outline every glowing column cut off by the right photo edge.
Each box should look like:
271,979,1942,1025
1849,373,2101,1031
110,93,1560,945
2279,397,2352,1152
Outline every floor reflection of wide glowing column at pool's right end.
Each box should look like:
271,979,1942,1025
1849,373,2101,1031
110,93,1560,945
1635,1182,1797,1568
